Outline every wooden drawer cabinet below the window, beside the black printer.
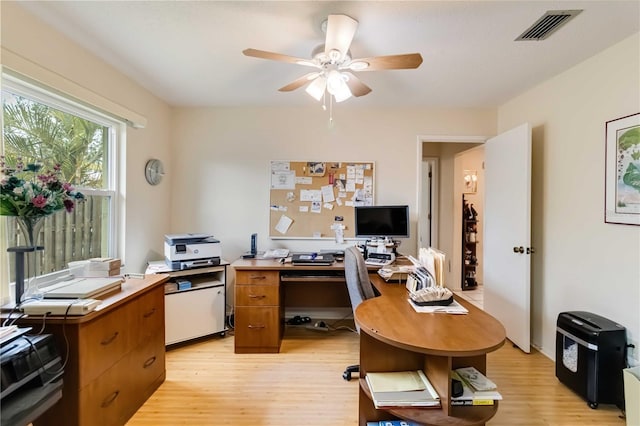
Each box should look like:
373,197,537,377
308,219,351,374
9,274,168,426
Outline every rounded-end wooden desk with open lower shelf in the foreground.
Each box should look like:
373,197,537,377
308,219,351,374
355,274,506,426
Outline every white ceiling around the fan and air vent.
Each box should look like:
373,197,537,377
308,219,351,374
15,0,640,108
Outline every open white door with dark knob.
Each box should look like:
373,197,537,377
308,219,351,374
483,123,531,353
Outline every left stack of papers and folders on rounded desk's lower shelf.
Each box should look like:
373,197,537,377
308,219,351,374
365,370,440,408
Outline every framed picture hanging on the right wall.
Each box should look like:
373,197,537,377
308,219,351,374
604,113,640,225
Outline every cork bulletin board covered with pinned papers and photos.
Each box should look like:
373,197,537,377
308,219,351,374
269,161,375,239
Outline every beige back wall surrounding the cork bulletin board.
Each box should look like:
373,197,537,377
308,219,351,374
172,103,496,259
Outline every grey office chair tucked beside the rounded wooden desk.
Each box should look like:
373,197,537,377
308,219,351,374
342,246,378,380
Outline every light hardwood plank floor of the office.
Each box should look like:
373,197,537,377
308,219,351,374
127,326,625,426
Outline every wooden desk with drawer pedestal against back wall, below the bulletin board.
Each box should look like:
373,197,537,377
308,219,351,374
231,259,351,353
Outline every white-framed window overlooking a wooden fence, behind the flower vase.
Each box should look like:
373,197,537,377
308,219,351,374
0,75,126,289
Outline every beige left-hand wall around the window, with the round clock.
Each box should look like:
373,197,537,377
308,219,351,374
0,2,173,286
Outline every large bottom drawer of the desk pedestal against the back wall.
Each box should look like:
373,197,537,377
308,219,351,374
234,306,282,353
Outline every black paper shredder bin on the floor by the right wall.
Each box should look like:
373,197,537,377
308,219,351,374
556,311,626,408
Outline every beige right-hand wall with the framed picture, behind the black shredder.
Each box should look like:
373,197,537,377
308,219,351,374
498,34,640,363
